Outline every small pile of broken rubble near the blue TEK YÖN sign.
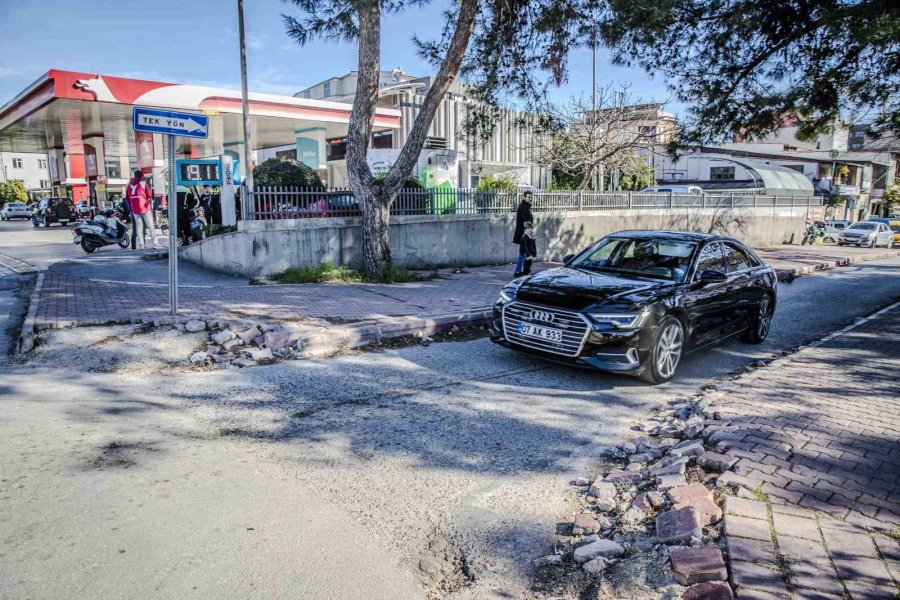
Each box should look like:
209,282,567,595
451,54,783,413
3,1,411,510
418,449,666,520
184,319,303,369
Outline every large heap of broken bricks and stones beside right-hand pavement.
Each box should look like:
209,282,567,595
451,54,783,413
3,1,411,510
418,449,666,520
536,399,738,600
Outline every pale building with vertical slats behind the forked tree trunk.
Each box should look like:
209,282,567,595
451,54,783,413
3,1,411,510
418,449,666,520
258,69,551,188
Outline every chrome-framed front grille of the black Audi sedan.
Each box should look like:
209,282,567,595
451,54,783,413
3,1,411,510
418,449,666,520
503,302,589,357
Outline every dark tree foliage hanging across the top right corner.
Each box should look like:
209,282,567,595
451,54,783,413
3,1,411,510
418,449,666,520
600,0,900,144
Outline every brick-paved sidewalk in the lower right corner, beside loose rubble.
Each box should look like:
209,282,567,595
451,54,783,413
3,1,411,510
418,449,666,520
705,305,900,600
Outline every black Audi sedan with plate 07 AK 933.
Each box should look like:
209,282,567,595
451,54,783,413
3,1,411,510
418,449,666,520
491,231,777,383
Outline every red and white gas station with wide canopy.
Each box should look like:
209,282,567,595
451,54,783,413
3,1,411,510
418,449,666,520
0,69,401,202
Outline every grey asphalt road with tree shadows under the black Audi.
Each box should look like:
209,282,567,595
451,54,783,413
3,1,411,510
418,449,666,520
0,259,900,599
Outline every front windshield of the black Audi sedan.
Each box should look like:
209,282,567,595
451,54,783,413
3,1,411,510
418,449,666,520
571,237,697,281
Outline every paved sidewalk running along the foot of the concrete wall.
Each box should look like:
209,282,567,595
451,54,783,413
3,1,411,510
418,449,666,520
29,246,900,328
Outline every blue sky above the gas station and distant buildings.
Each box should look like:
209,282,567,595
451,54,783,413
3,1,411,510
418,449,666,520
0,0,679,112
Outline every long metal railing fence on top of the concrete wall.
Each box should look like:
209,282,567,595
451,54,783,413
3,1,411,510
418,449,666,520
245,187,822,220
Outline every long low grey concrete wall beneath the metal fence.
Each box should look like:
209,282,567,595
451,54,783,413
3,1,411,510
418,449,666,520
181,206,807,277
